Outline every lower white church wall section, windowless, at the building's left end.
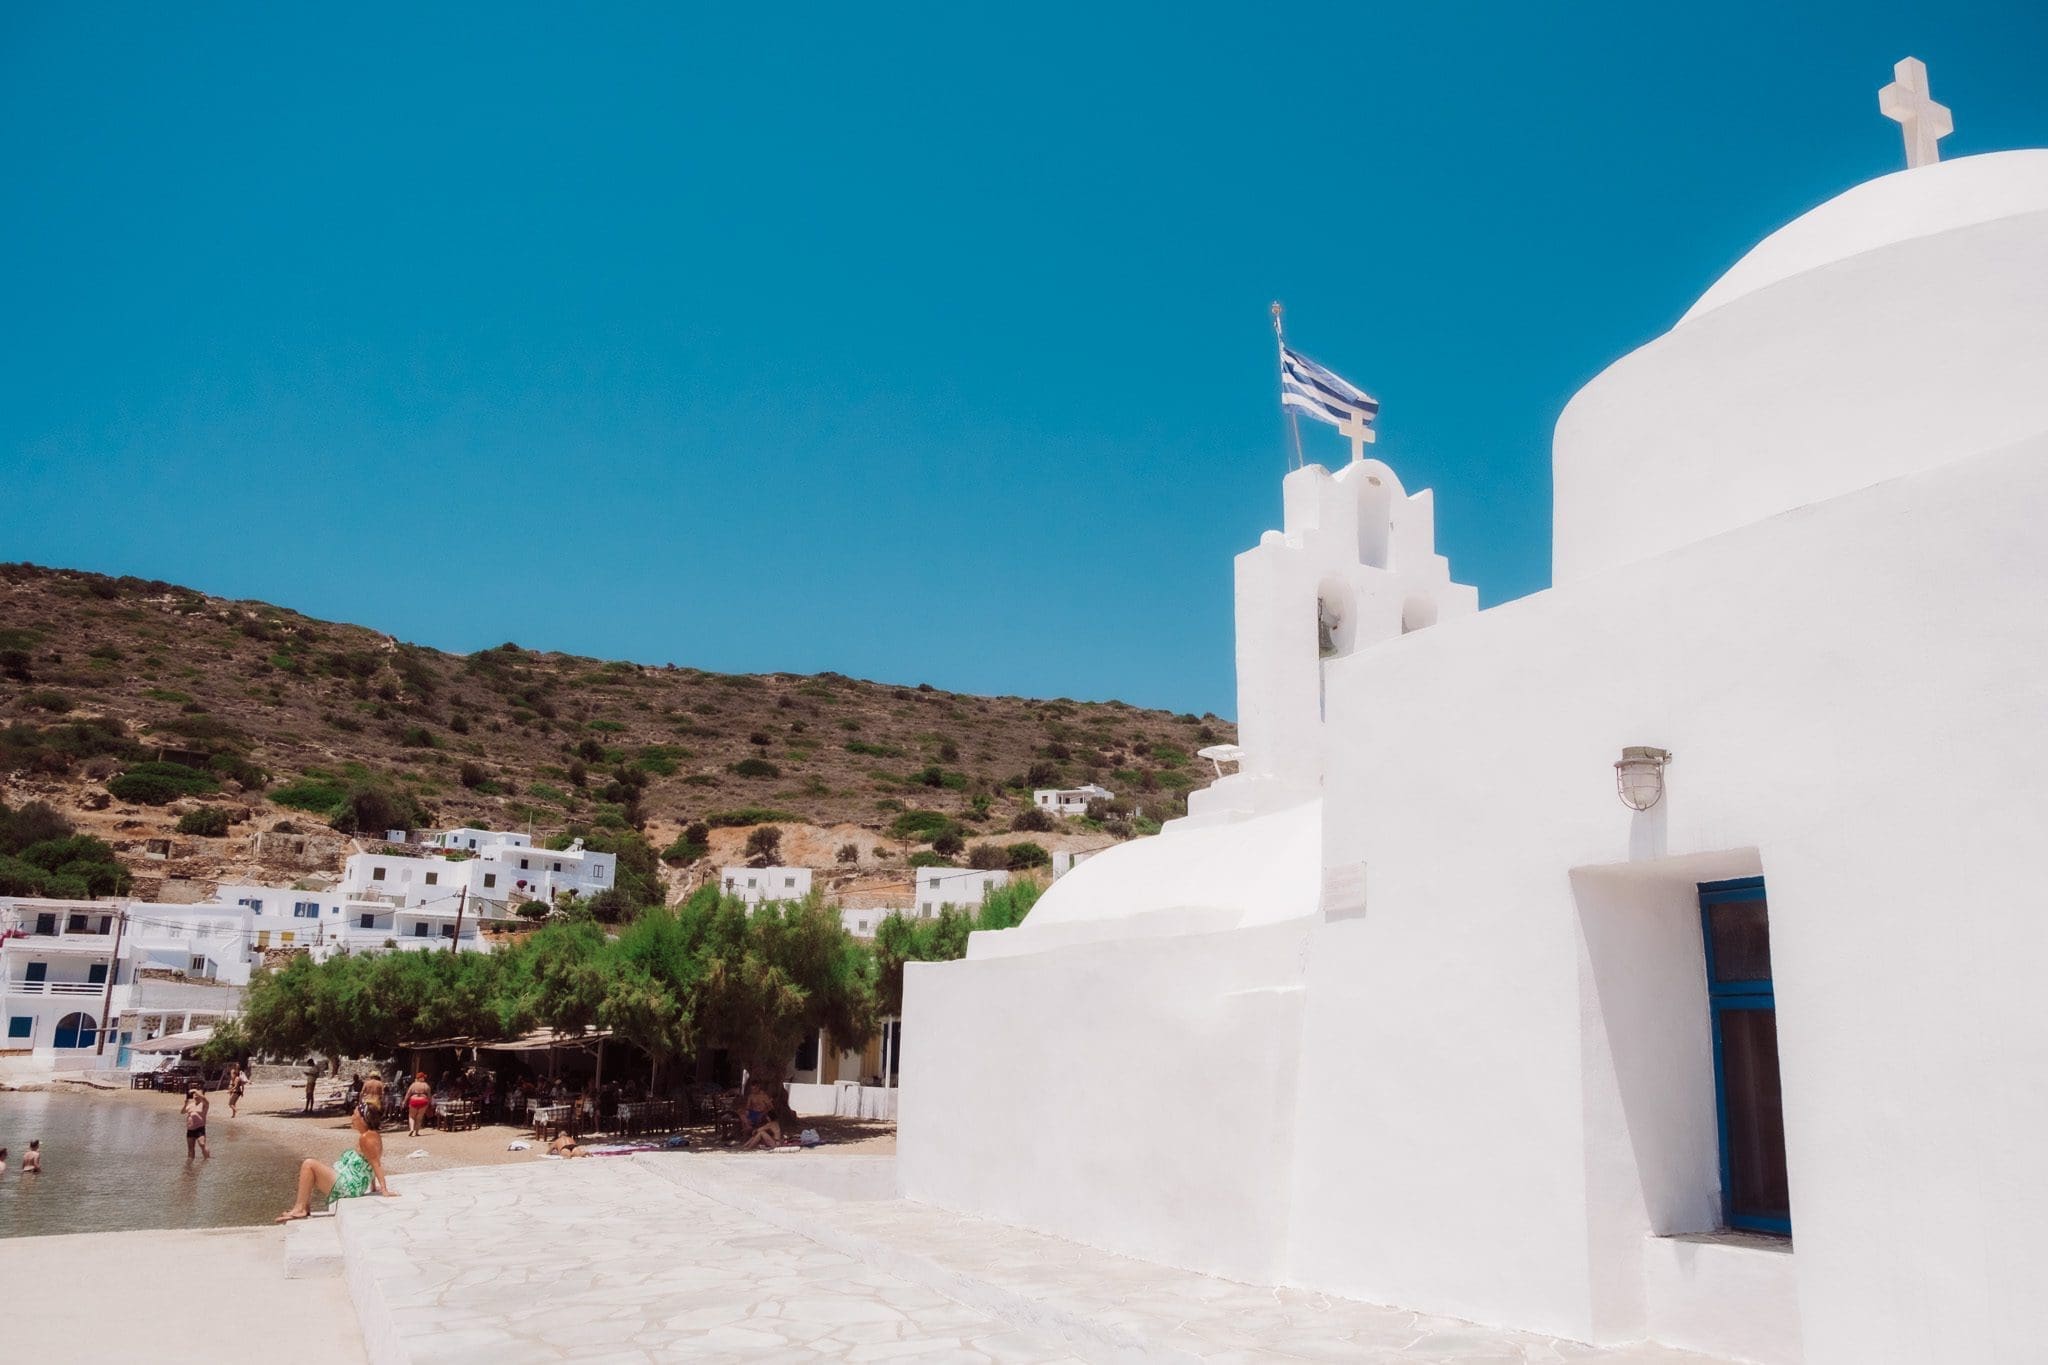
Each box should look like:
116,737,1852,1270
897,923,1309,1283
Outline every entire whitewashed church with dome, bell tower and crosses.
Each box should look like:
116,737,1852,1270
897,63,2048,1365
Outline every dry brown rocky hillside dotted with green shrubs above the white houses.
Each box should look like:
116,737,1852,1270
0,565,1235,892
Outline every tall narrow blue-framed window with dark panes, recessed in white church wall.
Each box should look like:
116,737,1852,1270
1700,876,1792,1236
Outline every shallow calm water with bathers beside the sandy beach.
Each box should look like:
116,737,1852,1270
0,1091,311,1236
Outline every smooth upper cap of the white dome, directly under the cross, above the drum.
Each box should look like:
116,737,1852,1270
1679,147,2048,323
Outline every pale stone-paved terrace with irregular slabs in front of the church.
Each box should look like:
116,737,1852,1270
340,1152,1744,1365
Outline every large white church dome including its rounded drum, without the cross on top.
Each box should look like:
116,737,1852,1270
1550,151,2048,583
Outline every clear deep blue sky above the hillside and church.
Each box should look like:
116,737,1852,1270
0,0,2048,714
